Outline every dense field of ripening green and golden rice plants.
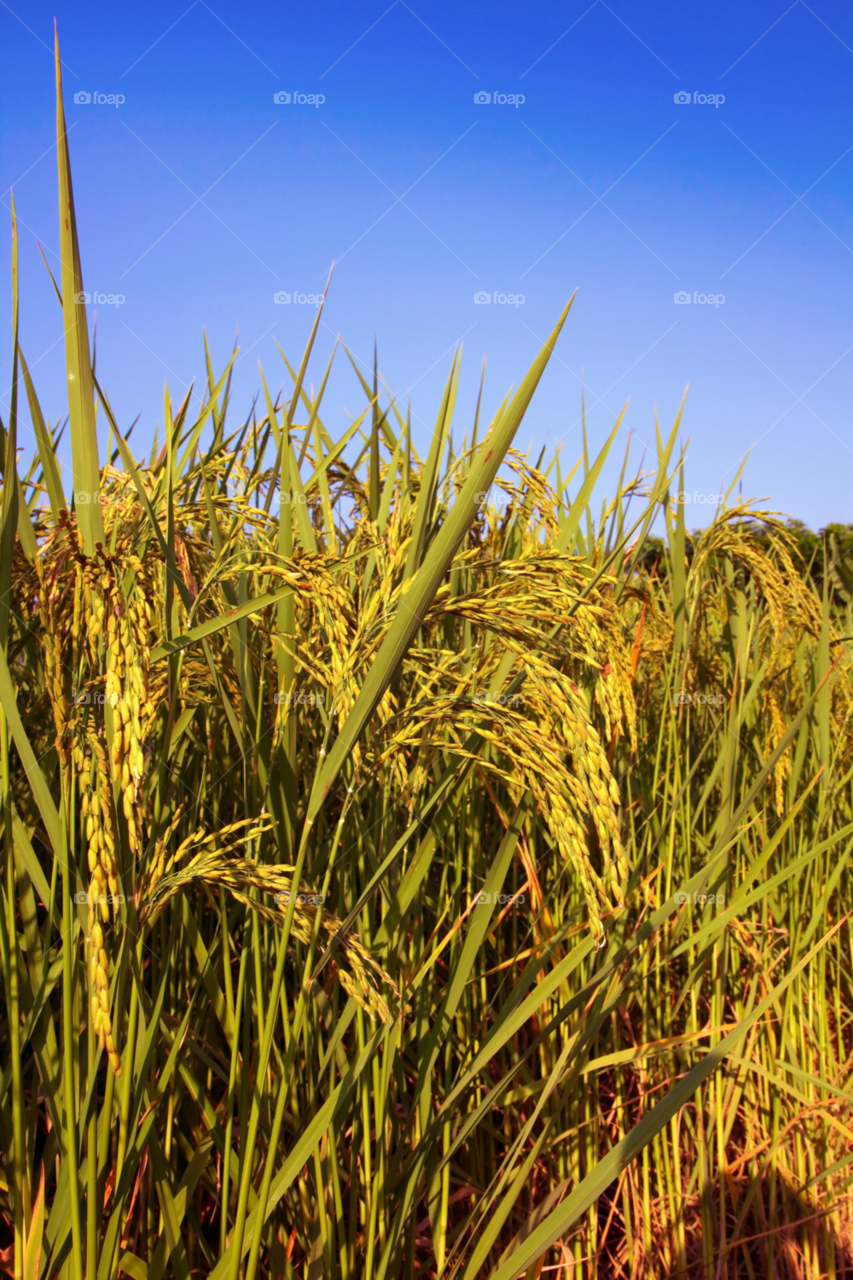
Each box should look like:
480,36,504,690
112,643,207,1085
0,37,853,1280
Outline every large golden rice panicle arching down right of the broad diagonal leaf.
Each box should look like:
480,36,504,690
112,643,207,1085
351,549,637,938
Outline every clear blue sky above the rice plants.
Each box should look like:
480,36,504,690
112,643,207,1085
0,0,853,527
